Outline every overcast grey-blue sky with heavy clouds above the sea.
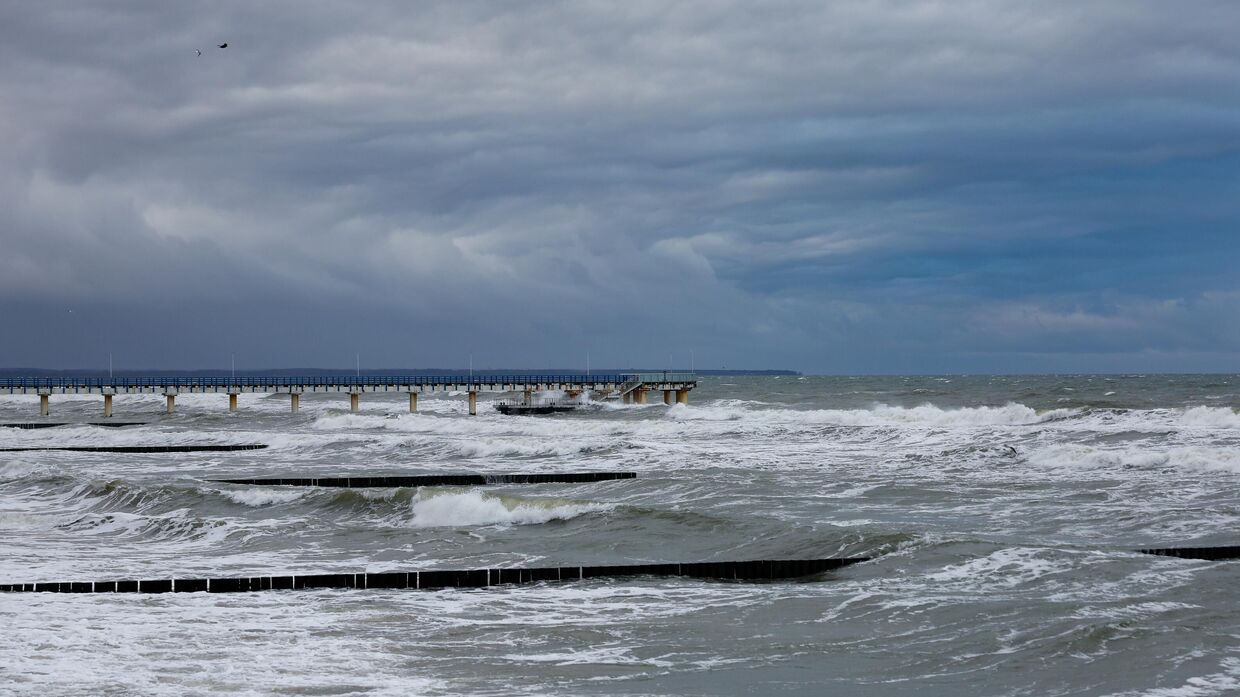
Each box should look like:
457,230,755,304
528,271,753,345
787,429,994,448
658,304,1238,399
0,0,1240,373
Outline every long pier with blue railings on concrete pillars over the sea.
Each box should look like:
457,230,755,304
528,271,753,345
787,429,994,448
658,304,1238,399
0,371,697,417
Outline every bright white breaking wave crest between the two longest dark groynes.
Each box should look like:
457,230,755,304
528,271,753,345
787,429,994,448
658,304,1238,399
409,490,615,527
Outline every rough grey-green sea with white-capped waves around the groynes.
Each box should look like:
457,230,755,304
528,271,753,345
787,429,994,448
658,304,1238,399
0,376,1240,697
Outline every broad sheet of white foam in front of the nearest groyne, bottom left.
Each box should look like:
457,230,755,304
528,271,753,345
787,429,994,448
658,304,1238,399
0,593,451,697
